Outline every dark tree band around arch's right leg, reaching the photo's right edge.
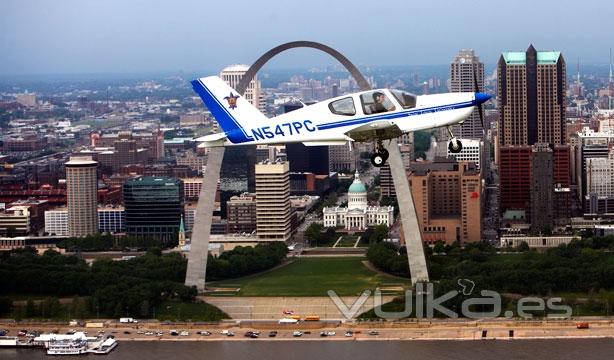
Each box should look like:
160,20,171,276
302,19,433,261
367,236,614,295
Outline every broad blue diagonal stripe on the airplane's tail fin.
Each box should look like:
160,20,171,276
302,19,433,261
190,79,254,144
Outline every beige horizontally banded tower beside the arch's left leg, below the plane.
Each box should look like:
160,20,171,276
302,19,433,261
256,162,292,241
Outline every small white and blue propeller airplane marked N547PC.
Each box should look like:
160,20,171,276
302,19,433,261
191,73,491,167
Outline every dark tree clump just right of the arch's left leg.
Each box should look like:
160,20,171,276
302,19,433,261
207,241,288,280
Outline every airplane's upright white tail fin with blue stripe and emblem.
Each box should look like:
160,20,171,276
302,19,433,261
191,76,266,143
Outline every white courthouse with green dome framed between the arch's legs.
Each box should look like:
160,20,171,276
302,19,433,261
322,171,394,231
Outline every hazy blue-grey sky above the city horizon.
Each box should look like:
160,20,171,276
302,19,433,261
0,0,614,74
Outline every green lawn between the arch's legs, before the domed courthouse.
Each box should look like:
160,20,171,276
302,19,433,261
209,257,410,296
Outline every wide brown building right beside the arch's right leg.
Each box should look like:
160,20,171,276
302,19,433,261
409,160,482,245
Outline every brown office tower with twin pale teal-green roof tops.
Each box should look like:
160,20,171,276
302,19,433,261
497,45,567,146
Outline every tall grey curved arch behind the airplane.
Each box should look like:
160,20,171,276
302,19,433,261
185,41,429,292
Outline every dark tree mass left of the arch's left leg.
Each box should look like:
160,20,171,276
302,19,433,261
0,249,229,320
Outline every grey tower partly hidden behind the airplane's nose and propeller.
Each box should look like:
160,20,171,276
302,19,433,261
450,50,484,140
